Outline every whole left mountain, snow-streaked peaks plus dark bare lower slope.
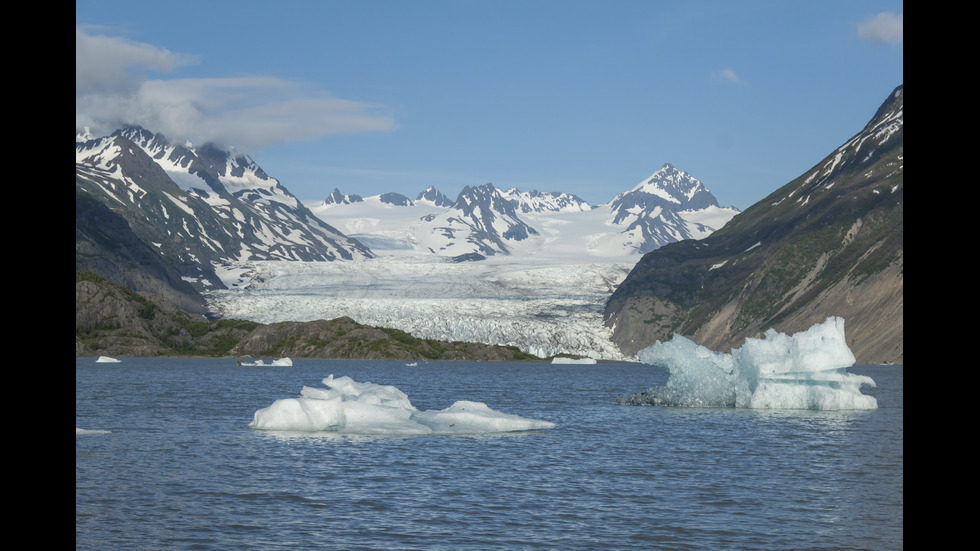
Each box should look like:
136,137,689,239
75,127,374,311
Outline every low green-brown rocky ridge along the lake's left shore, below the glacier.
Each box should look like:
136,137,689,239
75,270,541,361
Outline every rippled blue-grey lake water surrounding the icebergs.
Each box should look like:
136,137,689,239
75,358,904,550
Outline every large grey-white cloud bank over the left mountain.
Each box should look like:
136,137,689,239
75,27,395,151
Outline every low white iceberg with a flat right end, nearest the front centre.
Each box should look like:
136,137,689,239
248,375,555,436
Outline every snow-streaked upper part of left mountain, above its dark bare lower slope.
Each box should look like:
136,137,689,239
75,127,374,287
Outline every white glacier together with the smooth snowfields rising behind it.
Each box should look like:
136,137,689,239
206,167,737,360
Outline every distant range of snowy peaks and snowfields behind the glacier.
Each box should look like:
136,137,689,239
310,164,738,259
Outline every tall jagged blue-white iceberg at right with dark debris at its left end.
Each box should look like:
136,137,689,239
617,317,878,410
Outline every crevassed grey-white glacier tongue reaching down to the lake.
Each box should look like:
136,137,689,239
208,253,638,359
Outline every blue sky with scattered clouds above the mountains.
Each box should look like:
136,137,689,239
75,0,904,210
